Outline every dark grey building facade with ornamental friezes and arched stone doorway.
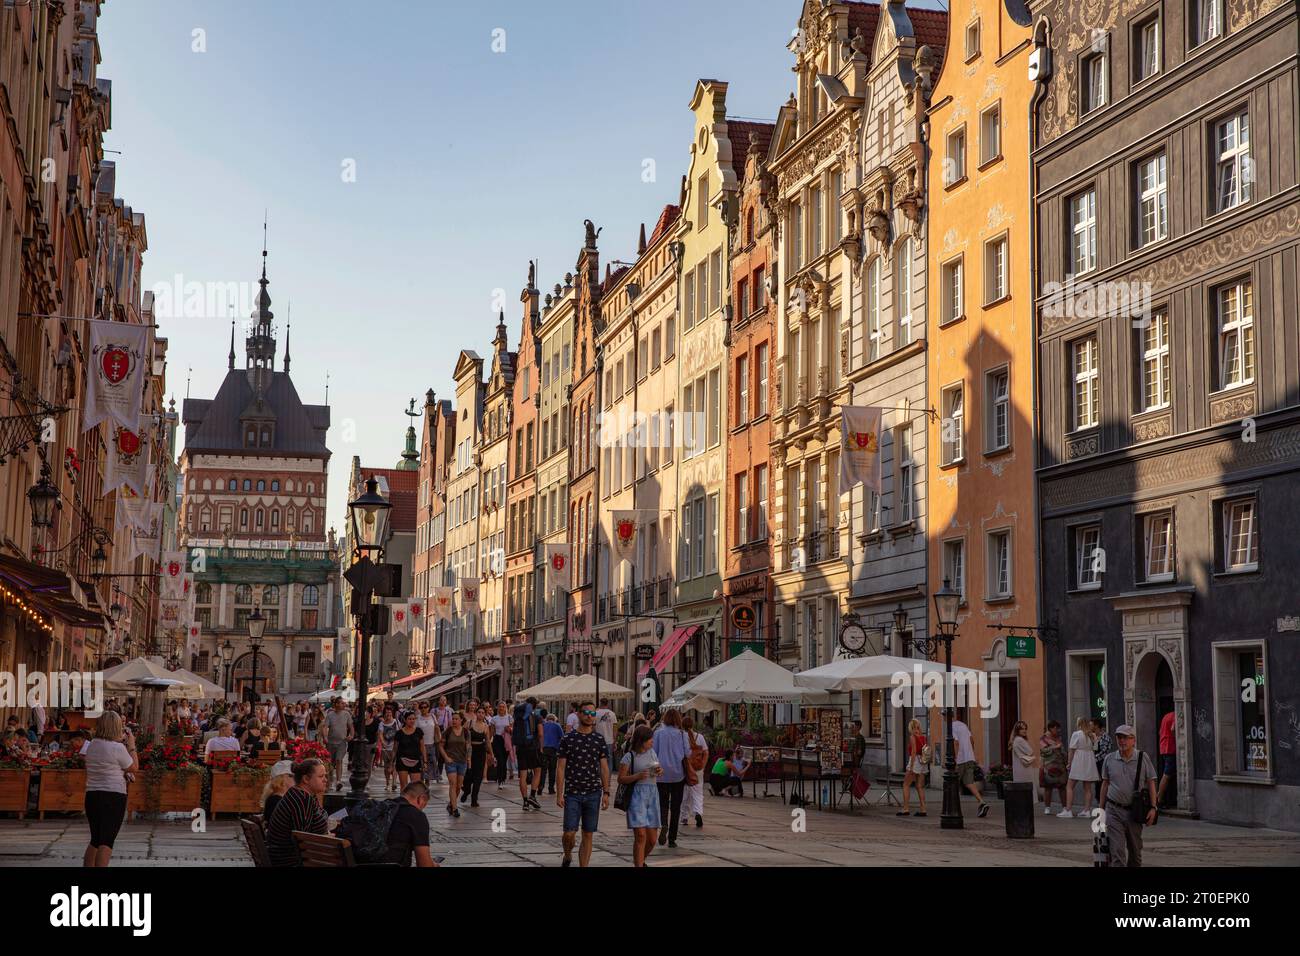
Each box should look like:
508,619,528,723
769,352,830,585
1030,0,1300,829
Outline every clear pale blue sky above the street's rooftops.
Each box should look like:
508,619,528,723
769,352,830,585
99,0,939,528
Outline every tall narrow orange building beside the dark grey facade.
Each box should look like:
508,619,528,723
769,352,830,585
927,0,1045,765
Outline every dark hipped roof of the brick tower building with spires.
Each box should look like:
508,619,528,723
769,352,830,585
181,368,330,458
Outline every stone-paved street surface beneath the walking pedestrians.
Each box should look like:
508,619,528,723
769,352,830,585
0,774,1300,868
